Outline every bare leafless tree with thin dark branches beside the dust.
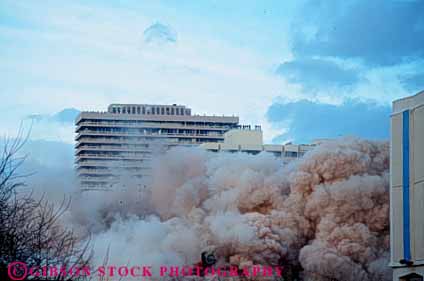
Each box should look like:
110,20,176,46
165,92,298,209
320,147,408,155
0,134,91,280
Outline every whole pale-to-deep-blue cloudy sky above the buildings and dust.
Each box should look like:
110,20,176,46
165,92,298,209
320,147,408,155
0,0,424,142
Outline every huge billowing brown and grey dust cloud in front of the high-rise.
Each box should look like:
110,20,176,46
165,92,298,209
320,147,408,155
74,138,391,280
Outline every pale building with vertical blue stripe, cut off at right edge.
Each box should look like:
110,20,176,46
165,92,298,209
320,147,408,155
390,92,424,281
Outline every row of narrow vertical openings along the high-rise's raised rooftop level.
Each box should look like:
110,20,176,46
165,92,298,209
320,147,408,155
112,106,191,115
